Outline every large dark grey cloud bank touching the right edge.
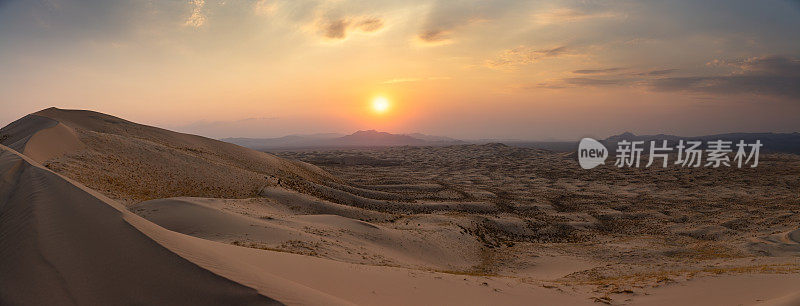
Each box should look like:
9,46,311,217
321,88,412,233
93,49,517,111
651,56,800,99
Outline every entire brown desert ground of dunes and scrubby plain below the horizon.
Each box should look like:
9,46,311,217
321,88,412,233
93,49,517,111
0,108,800,305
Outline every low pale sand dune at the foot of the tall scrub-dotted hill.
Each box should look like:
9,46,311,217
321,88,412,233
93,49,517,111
131,198,482,271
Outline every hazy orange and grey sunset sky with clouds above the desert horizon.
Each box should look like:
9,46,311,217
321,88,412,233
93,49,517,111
0,0,800,140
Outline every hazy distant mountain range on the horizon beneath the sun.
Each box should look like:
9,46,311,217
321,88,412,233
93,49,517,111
221,130,466,150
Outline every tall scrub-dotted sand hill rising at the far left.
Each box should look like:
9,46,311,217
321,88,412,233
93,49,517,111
0,108,335,204
